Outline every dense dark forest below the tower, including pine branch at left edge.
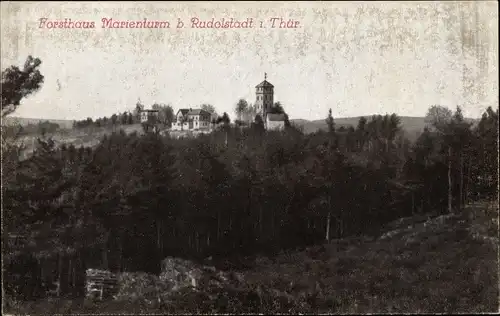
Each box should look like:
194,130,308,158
2,57,498,299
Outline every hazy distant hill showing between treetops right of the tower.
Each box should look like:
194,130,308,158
290,115,478,141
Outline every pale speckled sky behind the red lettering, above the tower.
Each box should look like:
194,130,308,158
0,1,498,120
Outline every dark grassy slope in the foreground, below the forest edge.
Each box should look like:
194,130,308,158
2,202,499,314
